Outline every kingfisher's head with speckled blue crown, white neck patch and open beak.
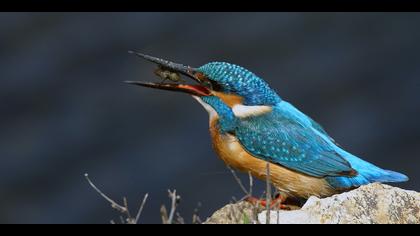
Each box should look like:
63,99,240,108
127,52,281,125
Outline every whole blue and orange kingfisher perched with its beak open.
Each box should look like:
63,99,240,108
126,51,408,208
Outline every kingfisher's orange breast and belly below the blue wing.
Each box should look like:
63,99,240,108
210,119,337,198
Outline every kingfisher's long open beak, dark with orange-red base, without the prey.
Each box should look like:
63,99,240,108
125,51,211,96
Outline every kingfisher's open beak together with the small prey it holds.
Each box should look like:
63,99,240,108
125,51,211,97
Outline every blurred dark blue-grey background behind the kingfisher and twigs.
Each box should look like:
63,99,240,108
0,13,420,223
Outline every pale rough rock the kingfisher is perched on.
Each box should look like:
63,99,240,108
205,183,420,224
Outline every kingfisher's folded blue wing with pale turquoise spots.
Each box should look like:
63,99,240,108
235,103,356,177
